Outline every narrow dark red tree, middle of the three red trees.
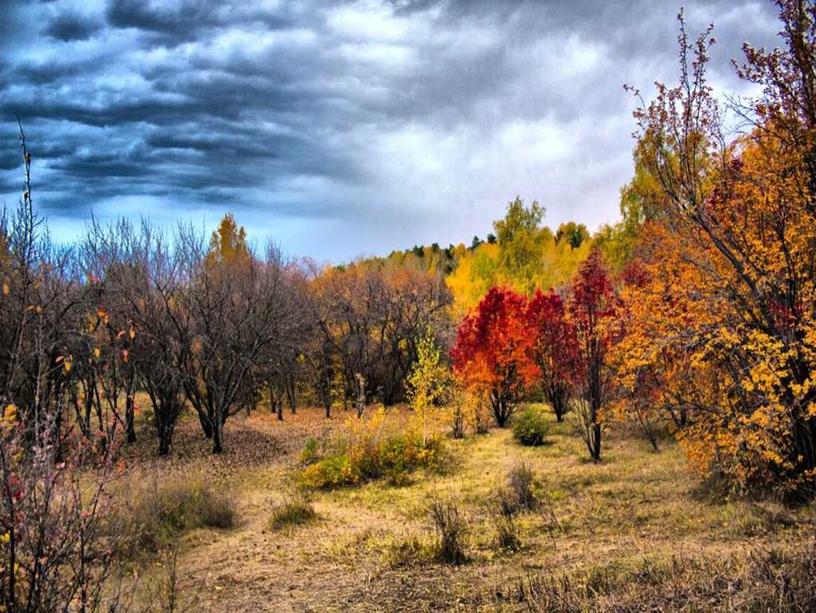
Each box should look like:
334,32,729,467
527,290,580,421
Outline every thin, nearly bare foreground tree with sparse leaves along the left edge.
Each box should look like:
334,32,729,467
0,122,127,612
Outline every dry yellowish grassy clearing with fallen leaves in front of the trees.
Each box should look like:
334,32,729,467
119,409,816,611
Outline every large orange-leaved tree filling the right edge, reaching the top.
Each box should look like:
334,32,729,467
636,0,816,496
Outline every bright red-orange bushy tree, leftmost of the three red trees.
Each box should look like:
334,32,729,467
451,288,535,428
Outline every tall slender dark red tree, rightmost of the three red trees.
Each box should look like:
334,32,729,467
568,250,619,462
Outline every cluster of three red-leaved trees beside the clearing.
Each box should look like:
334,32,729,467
452,251,620,450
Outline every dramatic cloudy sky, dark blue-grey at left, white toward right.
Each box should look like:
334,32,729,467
0,0,779,261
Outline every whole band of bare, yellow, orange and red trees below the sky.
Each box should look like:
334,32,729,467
0,0,816,610
